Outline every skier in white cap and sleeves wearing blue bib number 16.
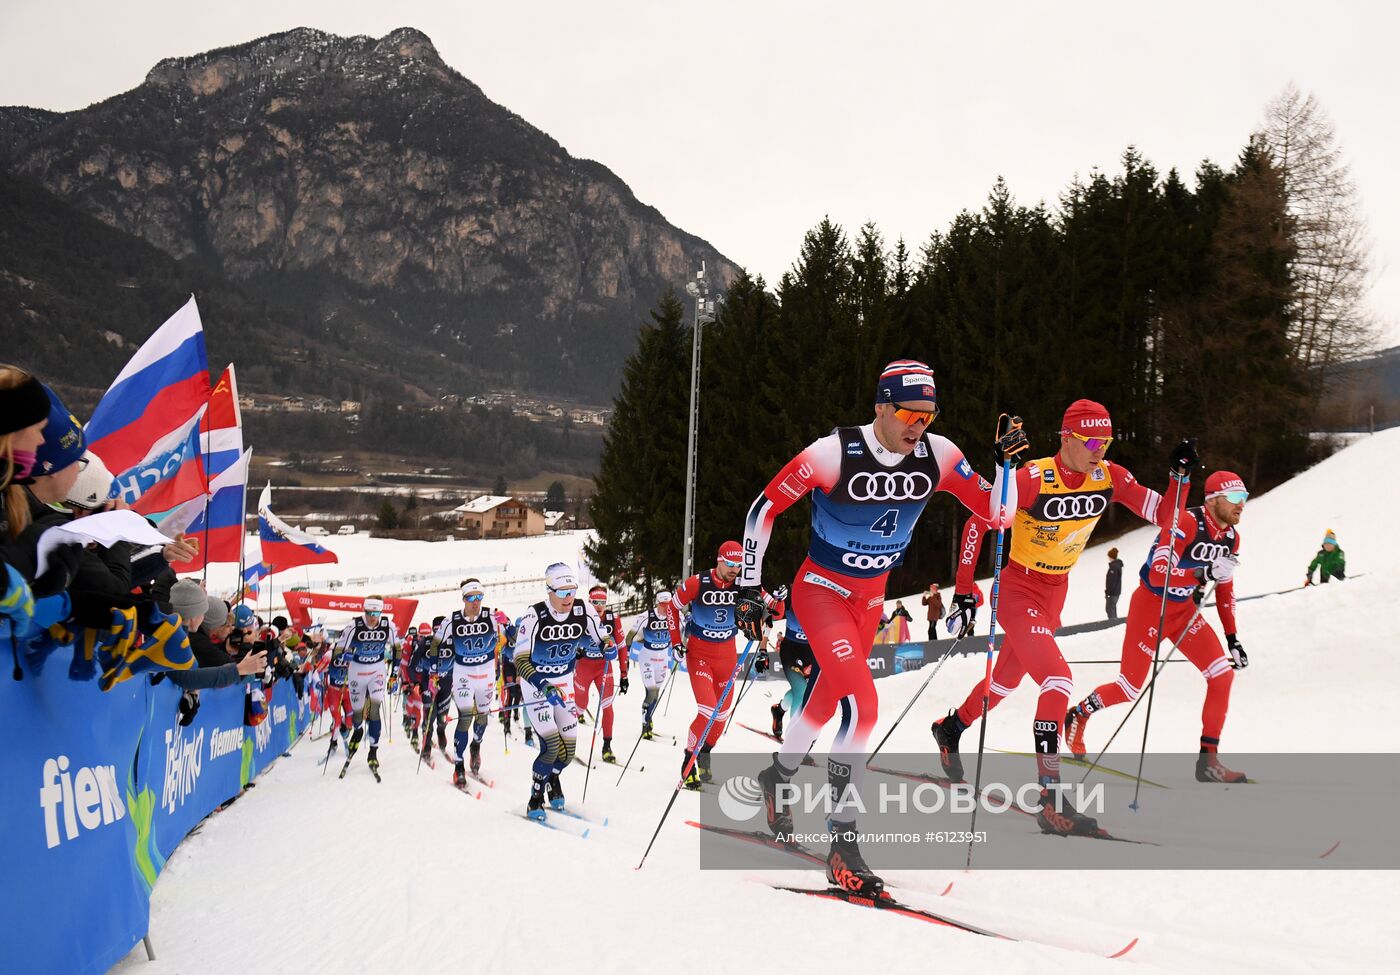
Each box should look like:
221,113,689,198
515,562,612,821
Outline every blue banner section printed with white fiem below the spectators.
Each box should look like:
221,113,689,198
0,651,150,972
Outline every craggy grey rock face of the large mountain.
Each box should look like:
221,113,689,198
0,28,736,402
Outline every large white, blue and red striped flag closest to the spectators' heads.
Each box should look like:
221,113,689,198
85,296,210,511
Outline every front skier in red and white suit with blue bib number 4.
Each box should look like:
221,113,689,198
736,359,1026,894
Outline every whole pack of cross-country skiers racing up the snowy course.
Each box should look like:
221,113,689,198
315,360,1249,895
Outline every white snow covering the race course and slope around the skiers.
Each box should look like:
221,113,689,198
118,430,1400,975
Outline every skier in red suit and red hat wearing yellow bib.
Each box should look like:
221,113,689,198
932,399,1196,835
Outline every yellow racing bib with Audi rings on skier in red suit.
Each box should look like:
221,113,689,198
1011,457,1113,576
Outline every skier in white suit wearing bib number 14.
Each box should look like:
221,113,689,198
433,579,501,787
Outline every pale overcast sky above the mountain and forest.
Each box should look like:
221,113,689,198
0,0,1400,343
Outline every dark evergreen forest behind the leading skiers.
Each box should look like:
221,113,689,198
589,137,1319,593
